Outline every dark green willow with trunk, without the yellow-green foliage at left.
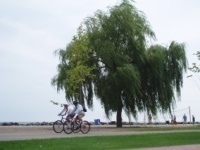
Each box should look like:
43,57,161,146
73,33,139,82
85,0,187,127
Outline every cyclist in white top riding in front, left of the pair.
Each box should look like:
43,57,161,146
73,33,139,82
58,104,75,121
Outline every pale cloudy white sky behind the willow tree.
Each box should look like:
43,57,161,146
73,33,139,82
0,0,200,122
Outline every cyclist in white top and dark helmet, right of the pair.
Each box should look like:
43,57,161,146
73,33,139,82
72,101,85,121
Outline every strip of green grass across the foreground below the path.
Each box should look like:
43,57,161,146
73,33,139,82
0,132,200,150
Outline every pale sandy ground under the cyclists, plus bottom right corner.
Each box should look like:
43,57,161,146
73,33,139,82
0,125,200,150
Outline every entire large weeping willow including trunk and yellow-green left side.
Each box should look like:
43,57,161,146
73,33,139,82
52,0,187,127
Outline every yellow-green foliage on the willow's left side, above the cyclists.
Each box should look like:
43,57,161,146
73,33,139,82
51,25,95,107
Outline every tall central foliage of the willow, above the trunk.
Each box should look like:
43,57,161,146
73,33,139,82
85,1,155,122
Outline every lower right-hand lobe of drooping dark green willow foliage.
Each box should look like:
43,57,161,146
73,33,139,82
141,41,187,115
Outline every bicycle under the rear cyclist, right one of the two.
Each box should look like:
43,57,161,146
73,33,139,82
63,120,90,134
